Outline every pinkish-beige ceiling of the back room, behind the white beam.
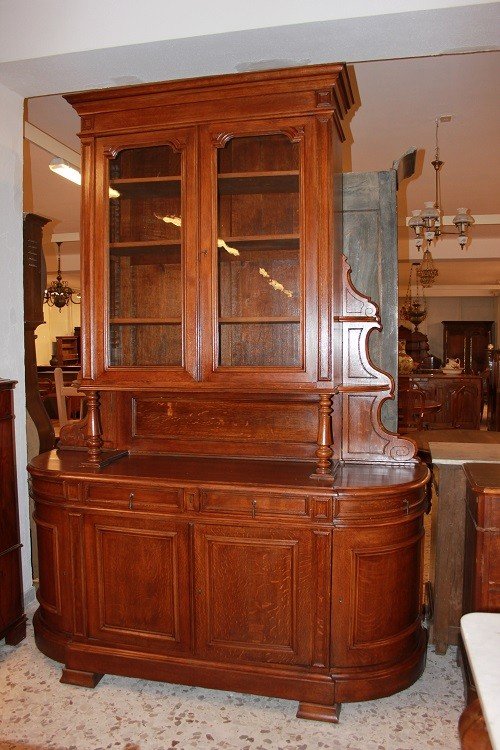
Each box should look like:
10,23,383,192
25,52,500,293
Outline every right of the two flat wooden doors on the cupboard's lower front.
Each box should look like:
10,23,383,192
191,524,329,665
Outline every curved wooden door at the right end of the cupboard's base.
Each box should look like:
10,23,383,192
332,518,423,668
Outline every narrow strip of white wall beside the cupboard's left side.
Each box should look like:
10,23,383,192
0,84,32,592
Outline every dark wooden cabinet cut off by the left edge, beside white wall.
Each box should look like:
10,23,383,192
0,380,26,645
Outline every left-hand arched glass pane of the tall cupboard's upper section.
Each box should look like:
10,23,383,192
109,146,183,367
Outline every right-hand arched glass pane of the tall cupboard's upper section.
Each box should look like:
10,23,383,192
218,135,302,367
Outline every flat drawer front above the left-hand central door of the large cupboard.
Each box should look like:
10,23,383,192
83,483,183,513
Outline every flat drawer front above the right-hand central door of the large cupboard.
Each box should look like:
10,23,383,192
200,490,310,518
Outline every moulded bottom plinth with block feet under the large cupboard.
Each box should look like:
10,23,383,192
34,611,427,723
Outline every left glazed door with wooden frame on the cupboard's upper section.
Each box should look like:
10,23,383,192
82,129,198,387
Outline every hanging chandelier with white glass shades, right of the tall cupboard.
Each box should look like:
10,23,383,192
408,115,474,287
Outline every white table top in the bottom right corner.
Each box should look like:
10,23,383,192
460,612,500,750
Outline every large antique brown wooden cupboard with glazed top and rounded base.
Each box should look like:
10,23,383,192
30,64,428,721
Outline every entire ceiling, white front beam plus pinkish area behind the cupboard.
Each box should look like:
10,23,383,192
5,0,494,295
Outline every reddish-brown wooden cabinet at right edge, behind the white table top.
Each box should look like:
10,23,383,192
463,463,500,614
